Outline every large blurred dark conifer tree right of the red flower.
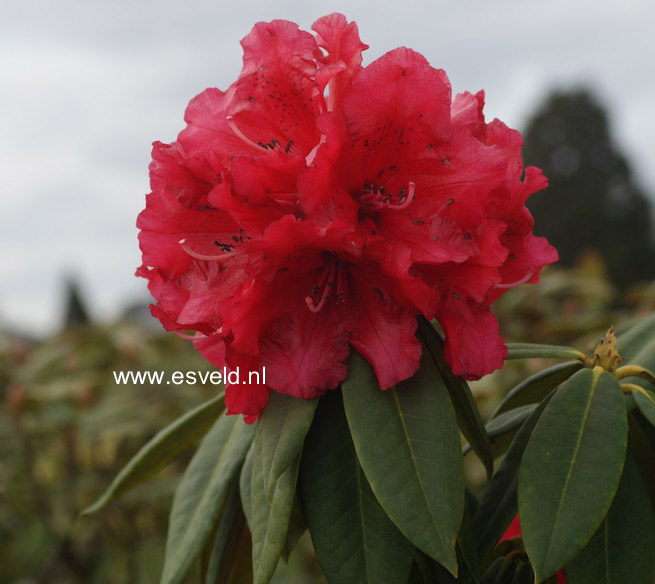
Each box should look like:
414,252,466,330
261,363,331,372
524,90,655,287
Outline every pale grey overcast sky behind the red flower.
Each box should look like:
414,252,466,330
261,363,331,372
0,0,655,333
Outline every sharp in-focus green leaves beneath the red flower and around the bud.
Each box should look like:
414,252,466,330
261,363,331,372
84,314,655,584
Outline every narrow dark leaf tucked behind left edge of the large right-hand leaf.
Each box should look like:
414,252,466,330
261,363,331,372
473,395,552,558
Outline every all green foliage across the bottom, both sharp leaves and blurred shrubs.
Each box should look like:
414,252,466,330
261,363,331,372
0,266,655,584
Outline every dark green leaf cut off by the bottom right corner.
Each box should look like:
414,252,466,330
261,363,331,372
566,451,655,584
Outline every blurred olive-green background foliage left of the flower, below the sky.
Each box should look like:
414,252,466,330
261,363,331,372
0,323,211,584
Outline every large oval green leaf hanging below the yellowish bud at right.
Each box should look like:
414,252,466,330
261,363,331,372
518,368,628,582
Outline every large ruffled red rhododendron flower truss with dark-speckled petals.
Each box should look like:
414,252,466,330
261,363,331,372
137,14,557,420
